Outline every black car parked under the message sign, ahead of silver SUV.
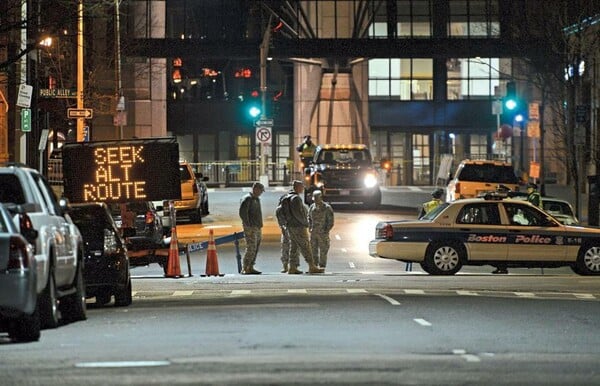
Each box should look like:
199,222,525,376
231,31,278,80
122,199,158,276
69,203,131,307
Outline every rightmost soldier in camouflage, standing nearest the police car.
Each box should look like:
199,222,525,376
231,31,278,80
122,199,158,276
308,190,333,269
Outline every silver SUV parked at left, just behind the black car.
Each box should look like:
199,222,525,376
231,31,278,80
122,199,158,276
0,163,87,328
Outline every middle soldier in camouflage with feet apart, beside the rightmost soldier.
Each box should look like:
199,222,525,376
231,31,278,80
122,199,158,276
287,181,324,275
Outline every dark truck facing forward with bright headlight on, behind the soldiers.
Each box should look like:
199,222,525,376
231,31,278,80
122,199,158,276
304,144,381,209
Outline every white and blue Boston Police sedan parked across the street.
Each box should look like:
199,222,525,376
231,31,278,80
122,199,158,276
369,194,600,275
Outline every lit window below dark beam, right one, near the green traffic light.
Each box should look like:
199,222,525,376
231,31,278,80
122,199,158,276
446,58,511,100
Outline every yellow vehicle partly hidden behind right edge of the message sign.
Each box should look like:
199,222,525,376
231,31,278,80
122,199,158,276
163,161,209,224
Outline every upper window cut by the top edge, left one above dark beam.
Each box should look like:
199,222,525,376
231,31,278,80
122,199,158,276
369,0,432,38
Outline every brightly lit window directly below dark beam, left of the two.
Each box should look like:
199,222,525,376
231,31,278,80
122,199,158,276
369,59,433,100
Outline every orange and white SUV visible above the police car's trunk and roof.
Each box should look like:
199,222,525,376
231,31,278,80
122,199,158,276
446,160,521,202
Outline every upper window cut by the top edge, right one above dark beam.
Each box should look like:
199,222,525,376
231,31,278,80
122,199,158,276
448,0,500,37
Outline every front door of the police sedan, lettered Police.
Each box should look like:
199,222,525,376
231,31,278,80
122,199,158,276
503,202,567,261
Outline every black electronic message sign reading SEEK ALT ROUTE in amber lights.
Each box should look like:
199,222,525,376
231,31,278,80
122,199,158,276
62,138,181,203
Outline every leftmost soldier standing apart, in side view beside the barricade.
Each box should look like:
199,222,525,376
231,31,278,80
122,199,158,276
239,182,265,275
